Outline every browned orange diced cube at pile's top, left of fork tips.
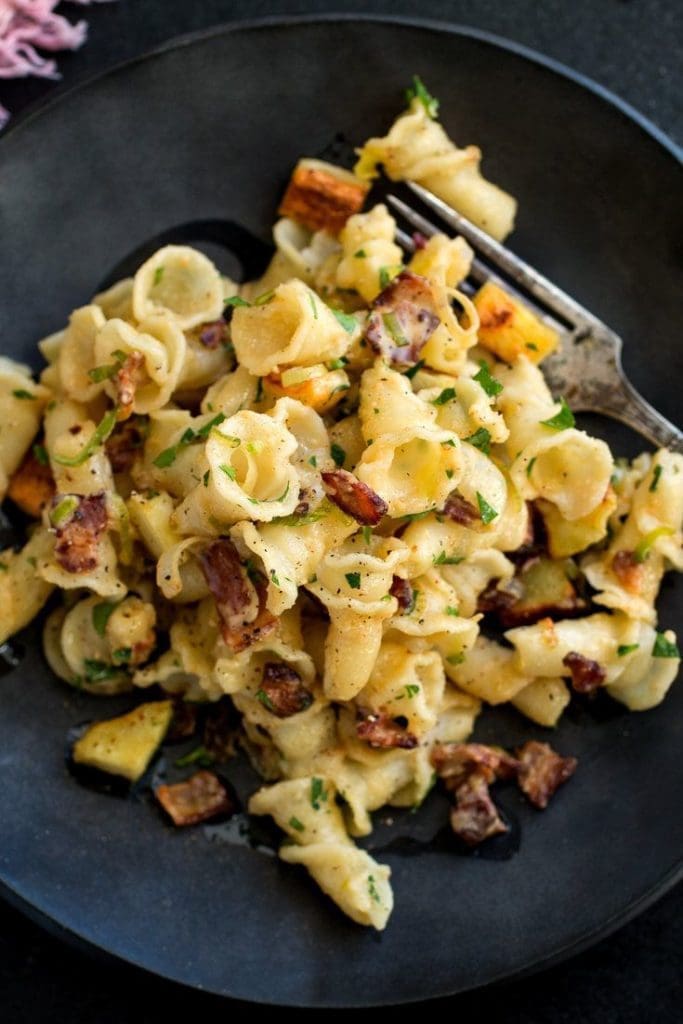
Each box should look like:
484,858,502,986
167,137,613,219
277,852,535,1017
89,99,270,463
279,158,370,234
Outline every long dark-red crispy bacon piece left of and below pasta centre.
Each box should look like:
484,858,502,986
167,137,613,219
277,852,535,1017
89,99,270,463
200,538,278,654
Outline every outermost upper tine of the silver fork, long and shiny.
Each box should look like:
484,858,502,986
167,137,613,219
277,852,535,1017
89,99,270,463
405,181,600,328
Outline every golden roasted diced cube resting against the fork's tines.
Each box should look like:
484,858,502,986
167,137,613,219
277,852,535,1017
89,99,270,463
474,281,559,362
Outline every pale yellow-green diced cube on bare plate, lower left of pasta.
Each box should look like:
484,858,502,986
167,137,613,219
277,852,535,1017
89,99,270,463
74,700,173,782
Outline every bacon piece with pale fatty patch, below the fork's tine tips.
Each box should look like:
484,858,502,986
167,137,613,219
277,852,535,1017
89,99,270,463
366,270,439,367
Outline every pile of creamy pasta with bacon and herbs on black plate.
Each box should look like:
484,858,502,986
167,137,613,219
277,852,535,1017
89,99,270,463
0,81,683,929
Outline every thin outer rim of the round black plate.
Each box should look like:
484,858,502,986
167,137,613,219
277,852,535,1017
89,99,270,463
0,11,683,1009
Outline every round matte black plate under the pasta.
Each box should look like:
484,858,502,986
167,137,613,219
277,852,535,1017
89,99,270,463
0,16,683,1006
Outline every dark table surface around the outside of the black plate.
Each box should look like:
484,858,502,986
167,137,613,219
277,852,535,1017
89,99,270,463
0,0,683,1024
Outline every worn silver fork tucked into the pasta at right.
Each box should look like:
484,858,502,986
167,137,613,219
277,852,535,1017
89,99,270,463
387,182,683,452
